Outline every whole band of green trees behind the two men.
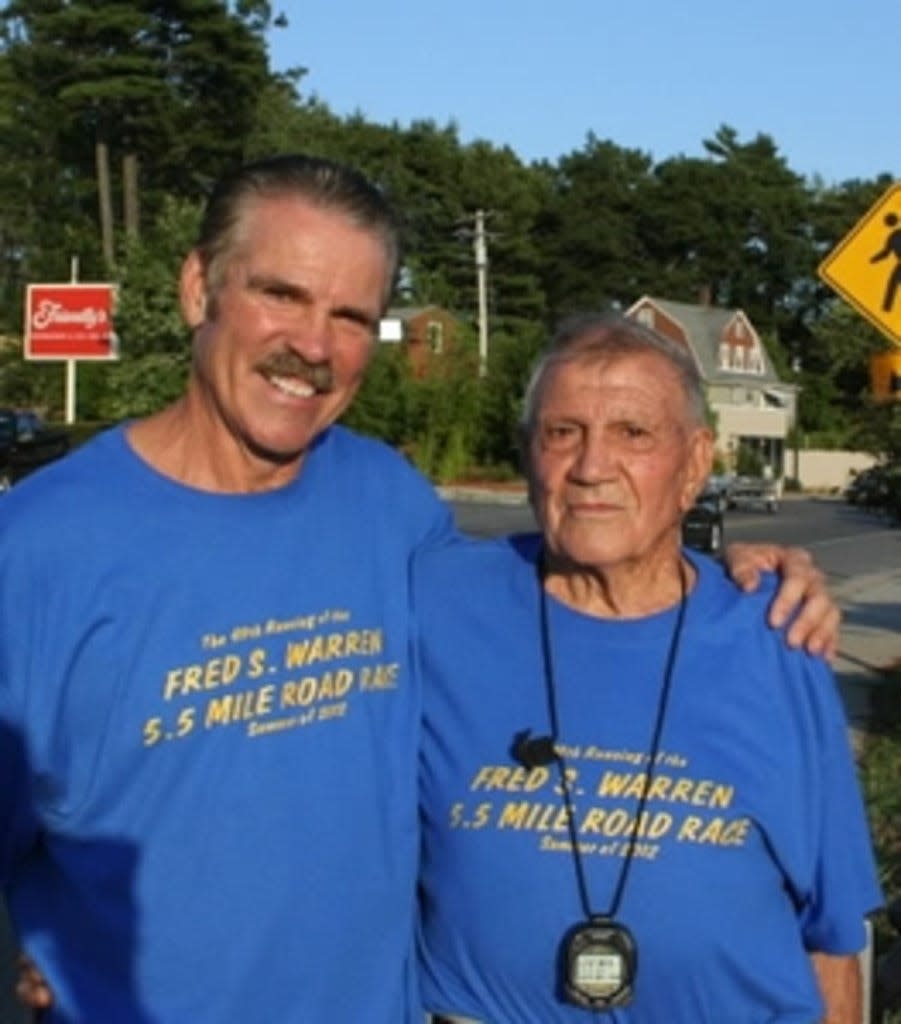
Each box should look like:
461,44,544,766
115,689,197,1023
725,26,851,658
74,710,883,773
0,12,898,476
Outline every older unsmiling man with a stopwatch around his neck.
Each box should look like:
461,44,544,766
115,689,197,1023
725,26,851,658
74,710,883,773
414,317,881,1024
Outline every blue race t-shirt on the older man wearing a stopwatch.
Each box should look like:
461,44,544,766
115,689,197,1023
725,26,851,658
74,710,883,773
414,538,881,1024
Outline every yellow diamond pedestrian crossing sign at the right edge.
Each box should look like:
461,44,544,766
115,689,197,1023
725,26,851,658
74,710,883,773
817,181,901,345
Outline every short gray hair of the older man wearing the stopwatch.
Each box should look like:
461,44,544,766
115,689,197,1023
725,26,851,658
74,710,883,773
519,313,706,447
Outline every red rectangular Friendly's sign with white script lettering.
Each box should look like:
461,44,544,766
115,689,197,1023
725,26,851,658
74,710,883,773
24,284,119,359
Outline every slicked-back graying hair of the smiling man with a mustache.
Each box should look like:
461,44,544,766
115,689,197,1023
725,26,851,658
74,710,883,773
196,154,400,306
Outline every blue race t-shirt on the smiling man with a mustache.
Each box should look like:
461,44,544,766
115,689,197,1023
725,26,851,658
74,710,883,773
0,419,449,1024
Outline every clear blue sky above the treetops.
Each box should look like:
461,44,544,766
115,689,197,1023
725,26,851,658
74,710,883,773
270,0,901,184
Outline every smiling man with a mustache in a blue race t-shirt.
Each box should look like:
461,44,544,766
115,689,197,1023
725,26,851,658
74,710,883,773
0,157,836,1024
